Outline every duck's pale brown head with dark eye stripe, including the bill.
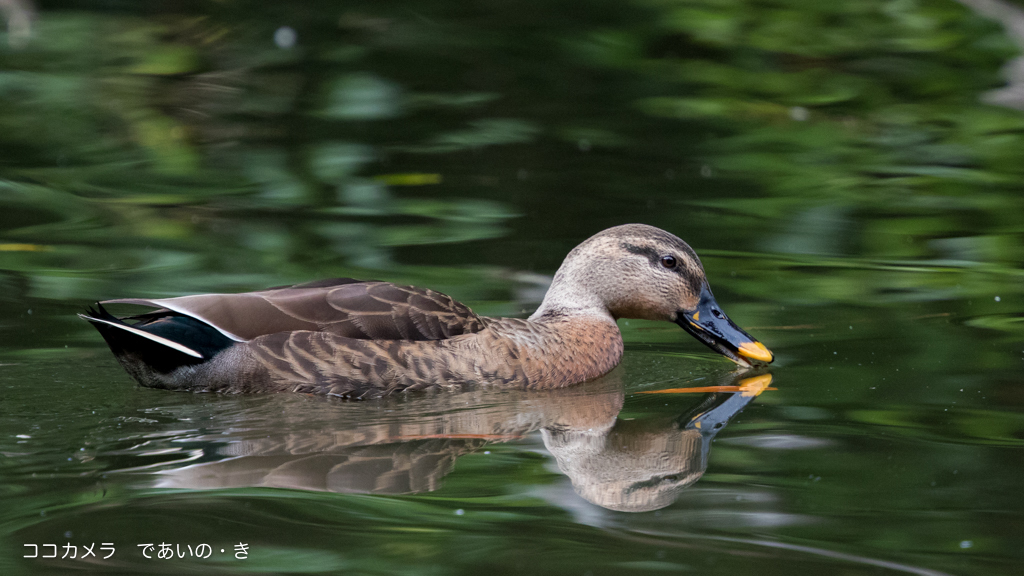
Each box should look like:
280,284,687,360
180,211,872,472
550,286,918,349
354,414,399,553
532,224,773,366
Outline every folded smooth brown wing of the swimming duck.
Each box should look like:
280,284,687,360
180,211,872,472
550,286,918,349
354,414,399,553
102,278,484,341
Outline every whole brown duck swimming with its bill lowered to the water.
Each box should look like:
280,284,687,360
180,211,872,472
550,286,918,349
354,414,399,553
79,223,774,400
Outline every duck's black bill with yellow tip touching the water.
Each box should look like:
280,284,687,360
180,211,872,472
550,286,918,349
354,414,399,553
676,284,775,366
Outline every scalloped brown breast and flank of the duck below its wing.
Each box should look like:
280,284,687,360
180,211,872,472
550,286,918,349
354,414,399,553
242,318,623,399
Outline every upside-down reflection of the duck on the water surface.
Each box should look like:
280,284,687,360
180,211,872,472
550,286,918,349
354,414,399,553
158,370,771,511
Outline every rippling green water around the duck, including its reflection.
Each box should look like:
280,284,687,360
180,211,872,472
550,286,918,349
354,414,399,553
0,0,1024,575
